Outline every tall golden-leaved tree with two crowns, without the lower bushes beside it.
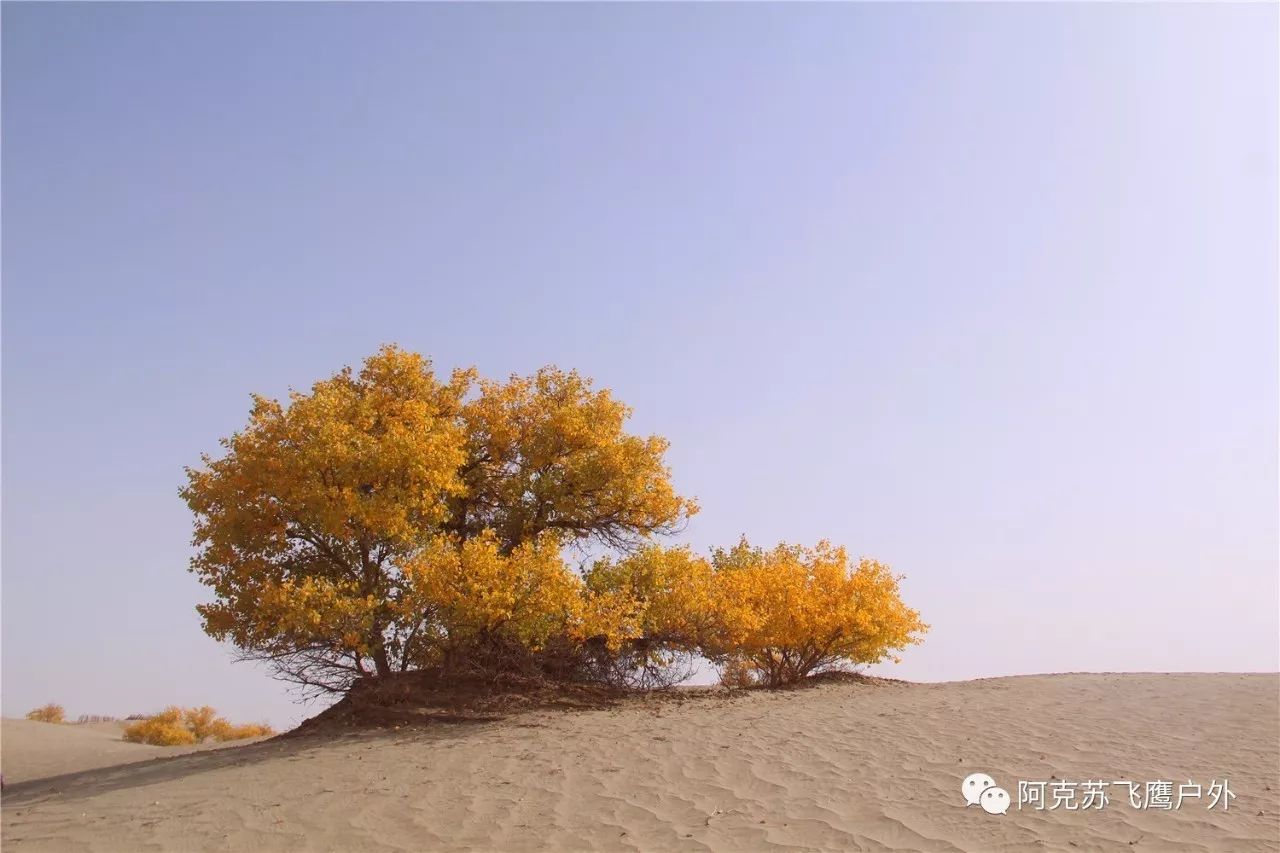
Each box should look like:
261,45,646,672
182,346,696,690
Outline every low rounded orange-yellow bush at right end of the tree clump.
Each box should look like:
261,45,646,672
705,540,928,685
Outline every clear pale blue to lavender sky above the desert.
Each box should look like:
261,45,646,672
0,4,1280,726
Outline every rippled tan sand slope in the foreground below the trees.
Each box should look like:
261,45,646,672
3,675,1280,853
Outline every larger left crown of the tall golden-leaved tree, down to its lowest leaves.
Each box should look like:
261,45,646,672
183,347,471,654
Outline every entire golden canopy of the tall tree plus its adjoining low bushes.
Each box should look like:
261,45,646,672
182,346,925,690
